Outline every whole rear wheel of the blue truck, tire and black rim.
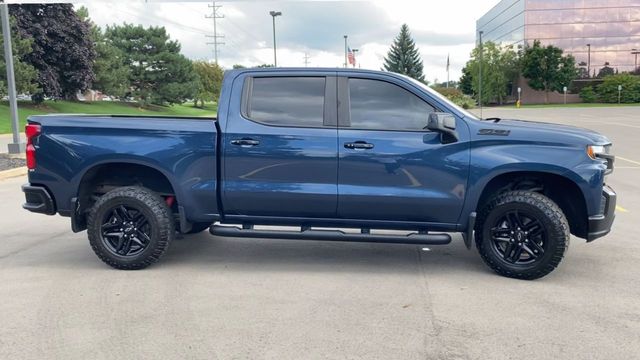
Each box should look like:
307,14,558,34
87,187,175,270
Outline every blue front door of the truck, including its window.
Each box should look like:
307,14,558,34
338,76,469,224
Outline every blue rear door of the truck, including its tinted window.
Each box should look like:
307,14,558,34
222,72,338,218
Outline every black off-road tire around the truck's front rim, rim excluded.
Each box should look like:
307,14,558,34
475,191,570,280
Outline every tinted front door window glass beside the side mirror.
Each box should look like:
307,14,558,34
349,79,434,131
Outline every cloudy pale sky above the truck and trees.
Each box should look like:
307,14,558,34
74,0,498,82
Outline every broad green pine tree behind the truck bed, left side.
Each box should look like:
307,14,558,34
105,23,198,105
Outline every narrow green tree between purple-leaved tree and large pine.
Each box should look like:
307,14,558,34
77,6,129,98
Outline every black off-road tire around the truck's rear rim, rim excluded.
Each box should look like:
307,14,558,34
87,186,175,270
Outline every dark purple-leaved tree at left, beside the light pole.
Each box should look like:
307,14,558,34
11,4,96,101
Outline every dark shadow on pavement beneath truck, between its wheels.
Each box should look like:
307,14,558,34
161,233,491,274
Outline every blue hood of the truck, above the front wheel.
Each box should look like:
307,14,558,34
483,119,611,145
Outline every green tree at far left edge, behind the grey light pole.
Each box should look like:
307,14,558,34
0,18,38,96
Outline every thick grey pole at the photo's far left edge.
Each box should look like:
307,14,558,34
0,1,25,154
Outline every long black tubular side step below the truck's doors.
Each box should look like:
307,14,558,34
209,225,451,245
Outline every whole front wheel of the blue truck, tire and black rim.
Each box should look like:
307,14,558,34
475,191,570,280
